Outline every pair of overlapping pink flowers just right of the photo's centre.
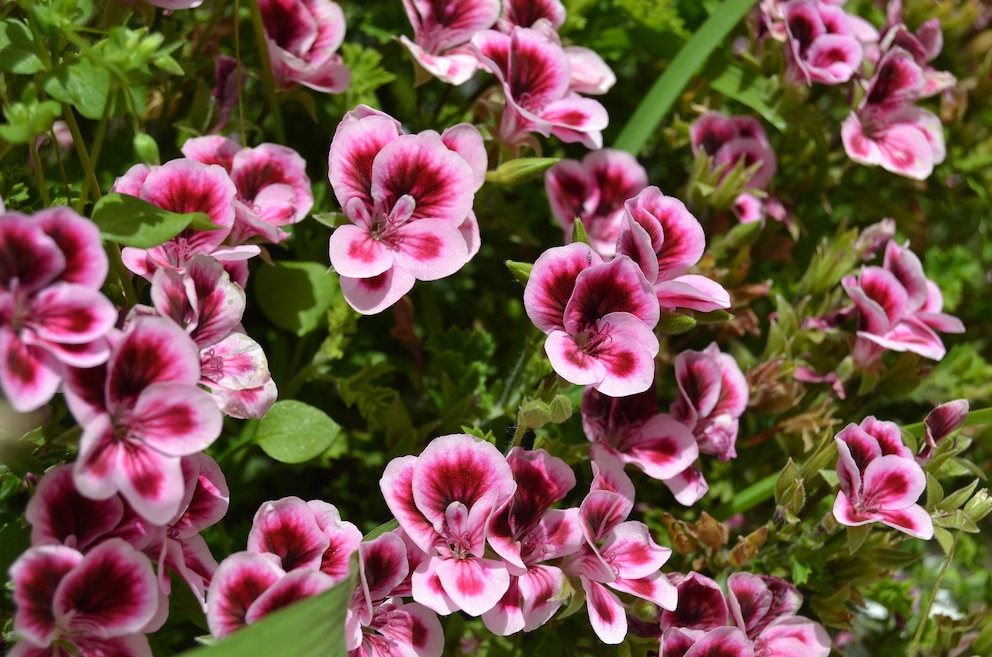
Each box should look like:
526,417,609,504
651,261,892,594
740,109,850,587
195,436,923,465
524,187,730,397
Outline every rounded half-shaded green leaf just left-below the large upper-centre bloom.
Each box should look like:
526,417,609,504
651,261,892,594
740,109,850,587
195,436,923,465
253,262,344,337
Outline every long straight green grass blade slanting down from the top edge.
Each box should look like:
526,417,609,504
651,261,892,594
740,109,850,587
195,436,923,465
613,0,756,155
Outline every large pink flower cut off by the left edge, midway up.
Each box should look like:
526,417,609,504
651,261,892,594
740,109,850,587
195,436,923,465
0,207,117,413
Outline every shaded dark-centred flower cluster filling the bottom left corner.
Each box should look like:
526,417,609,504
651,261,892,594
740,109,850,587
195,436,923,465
11,454,228,656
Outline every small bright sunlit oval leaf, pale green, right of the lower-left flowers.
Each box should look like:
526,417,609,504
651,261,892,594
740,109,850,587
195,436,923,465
255,399,341,463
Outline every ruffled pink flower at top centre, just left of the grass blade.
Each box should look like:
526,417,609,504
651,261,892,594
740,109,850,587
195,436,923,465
472,27,609,148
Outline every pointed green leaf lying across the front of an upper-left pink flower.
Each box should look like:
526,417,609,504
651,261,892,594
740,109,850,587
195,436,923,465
93,193,217,249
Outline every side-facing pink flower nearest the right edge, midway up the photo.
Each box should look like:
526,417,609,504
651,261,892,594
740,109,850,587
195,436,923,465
841,240,964,366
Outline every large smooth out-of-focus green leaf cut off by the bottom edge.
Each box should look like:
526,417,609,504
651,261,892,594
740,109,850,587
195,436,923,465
181,553,358,657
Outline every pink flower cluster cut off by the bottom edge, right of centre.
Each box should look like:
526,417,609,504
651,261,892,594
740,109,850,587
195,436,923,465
659,572,830,657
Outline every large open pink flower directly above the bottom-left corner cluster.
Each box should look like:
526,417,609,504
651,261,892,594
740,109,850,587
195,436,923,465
65,317,222,525
